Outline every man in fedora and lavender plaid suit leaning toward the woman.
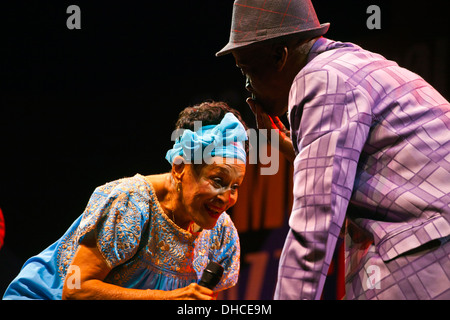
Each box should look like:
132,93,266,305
217,0,450,299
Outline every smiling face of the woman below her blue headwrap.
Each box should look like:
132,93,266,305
181,157,245,229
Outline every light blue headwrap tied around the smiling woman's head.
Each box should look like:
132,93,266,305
166,112,248,164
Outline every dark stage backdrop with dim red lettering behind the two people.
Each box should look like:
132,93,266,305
0,0,450,299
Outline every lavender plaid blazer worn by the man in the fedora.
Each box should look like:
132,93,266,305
275,38,450,299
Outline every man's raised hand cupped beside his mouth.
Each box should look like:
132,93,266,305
246,98,295,162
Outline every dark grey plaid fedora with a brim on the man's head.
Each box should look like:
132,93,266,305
216,0,330,56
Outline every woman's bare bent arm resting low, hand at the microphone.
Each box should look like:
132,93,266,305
62,235,213,300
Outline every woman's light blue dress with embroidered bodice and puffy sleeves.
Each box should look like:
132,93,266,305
3,174,240,299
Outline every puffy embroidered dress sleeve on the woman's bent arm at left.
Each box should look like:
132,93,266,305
78,177,149,268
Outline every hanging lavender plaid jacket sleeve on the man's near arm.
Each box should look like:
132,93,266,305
275,69,372,299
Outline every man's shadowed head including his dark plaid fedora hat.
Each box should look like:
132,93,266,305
216,0,329,115
